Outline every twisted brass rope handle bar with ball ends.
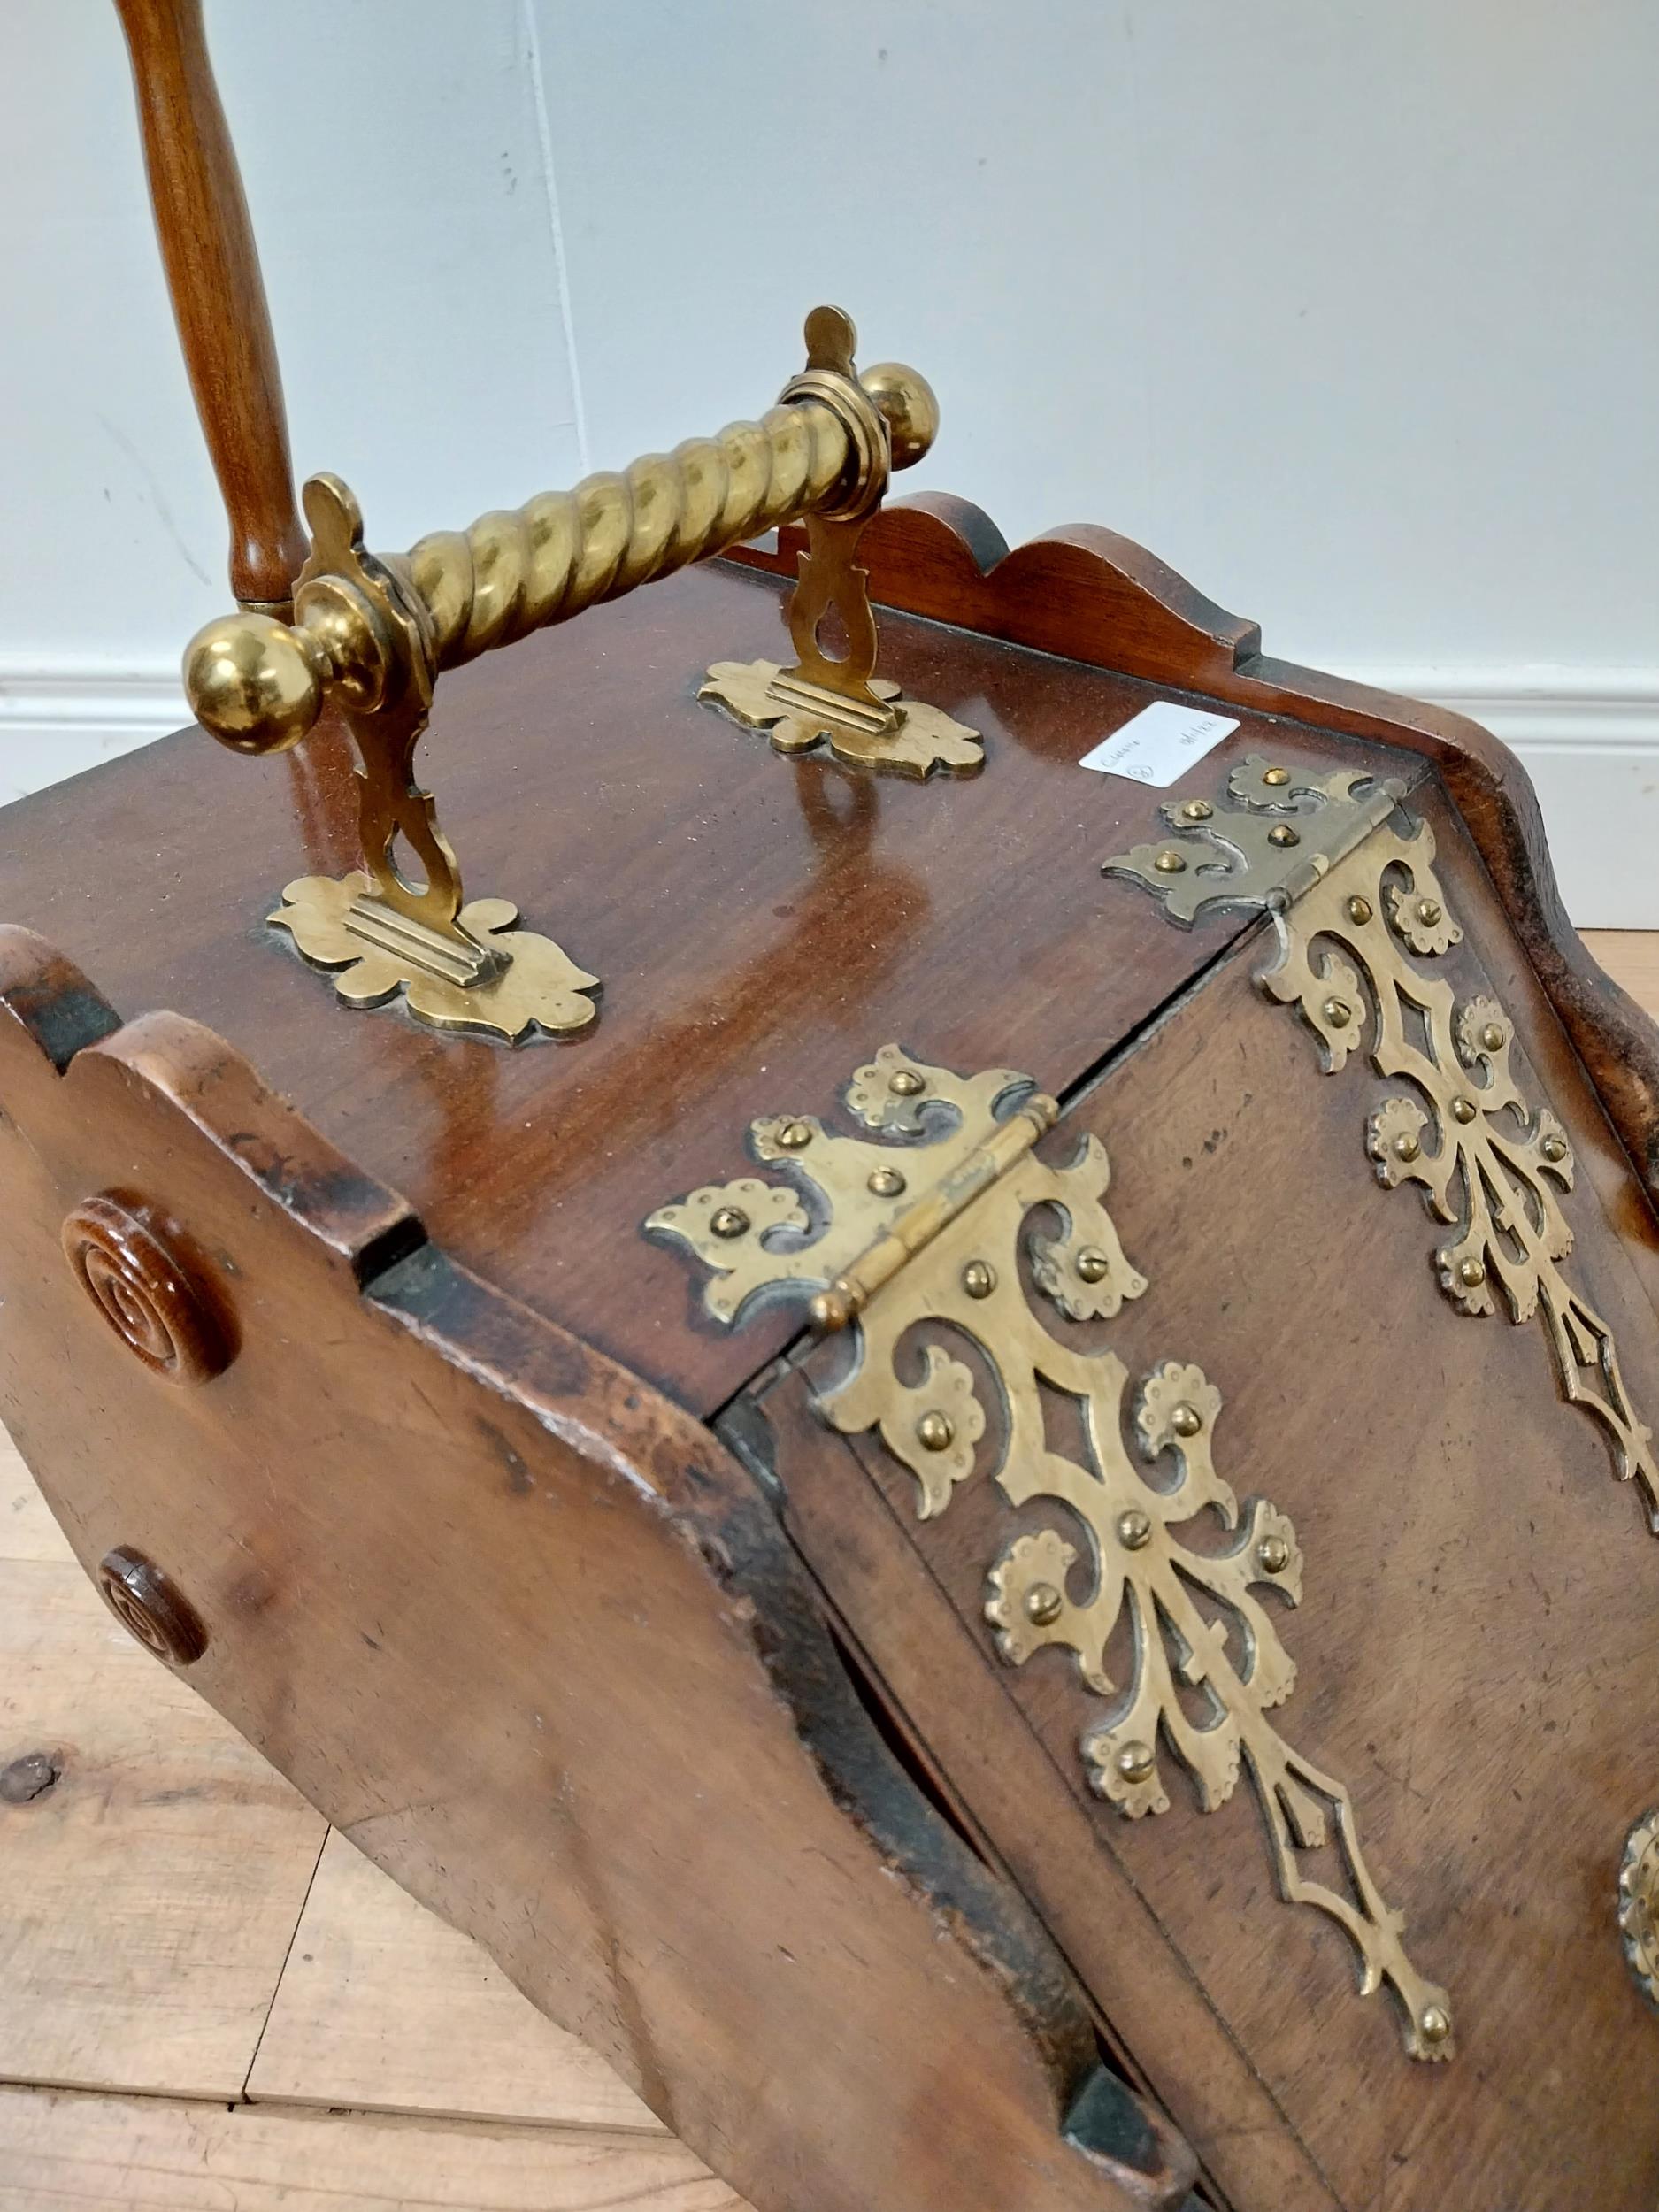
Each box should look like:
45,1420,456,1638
184,308,938,761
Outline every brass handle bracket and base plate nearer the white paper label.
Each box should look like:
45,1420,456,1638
697,308,985,779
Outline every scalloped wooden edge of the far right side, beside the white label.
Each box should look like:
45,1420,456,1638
726,491,1659,1206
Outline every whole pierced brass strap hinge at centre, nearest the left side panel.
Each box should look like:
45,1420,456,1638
646,1044,1451,2060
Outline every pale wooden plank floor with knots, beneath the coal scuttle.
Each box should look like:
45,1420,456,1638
0,932,1659,2212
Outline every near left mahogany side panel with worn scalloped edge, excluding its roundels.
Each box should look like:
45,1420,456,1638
0,932,1193,2212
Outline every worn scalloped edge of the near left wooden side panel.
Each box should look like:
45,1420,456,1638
0,929,1194,2208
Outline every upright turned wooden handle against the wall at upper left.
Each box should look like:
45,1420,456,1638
115,0,305,613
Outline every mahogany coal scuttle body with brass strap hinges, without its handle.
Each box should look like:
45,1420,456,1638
0,500,1659,2212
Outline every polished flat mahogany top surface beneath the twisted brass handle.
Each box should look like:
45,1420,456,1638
0,565,1420,1414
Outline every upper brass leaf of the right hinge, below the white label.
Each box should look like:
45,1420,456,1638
1102,752,1405,929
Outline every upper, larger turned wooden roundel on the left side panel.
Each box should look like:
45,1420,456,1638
65,1193,233,1383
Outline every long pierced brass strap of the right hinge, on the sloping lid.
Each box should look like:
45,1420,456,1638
1106,761,1659,1533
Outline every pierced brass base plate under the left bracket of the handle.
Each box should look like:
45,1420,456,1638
265,872,600,1044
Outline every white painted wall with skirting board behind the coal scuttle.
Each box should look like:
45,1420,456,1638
0,0,1659,925
